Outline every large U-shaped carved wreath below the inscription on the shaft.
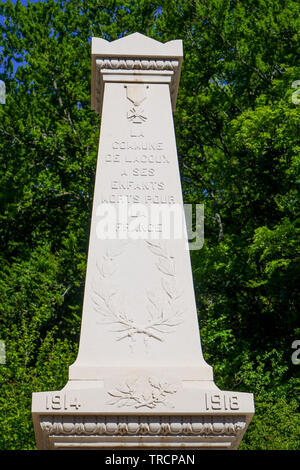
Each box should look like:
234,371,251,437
92,240,183,346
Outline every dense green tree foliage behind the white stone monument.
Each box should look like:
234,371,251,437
0,0,300,449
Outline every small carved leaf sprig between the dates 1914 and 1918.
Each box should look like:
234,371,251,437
107,377,177,409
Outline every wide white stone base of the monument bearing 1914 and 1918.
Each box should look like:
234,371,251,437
32,377,254,450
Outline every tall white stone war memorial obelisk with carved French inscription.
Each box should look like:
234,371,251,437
32,33,254,449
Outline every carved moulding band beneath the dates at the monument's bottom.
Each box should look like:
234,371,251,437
39,415,247,449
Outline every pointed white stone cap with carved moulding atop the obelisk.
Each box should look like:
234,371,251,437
91,33,183,114
